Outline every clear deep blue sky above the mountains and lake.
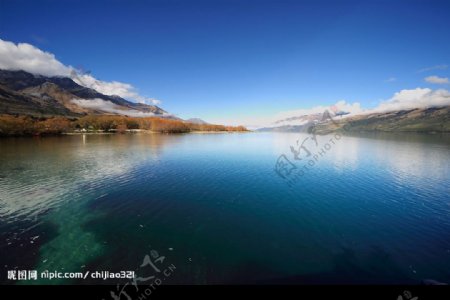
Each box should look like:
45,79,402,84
0,0,450,125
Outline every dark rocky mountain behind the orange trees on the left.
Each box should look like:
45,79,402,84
0,70,168,117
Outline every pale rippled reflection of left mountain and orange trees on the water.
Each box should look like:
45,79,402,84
0,134,177,221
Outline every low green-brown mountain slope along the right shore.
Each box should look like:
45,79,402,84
315,106,450,134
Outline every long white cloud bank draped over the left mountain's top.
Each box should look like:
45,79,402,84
0,39,161,105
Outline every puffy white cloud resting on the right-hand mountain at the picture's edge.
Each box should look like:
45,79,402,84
365,88,450,113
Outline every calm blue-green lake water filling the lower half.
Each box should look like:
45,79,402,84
0,133,450,284
